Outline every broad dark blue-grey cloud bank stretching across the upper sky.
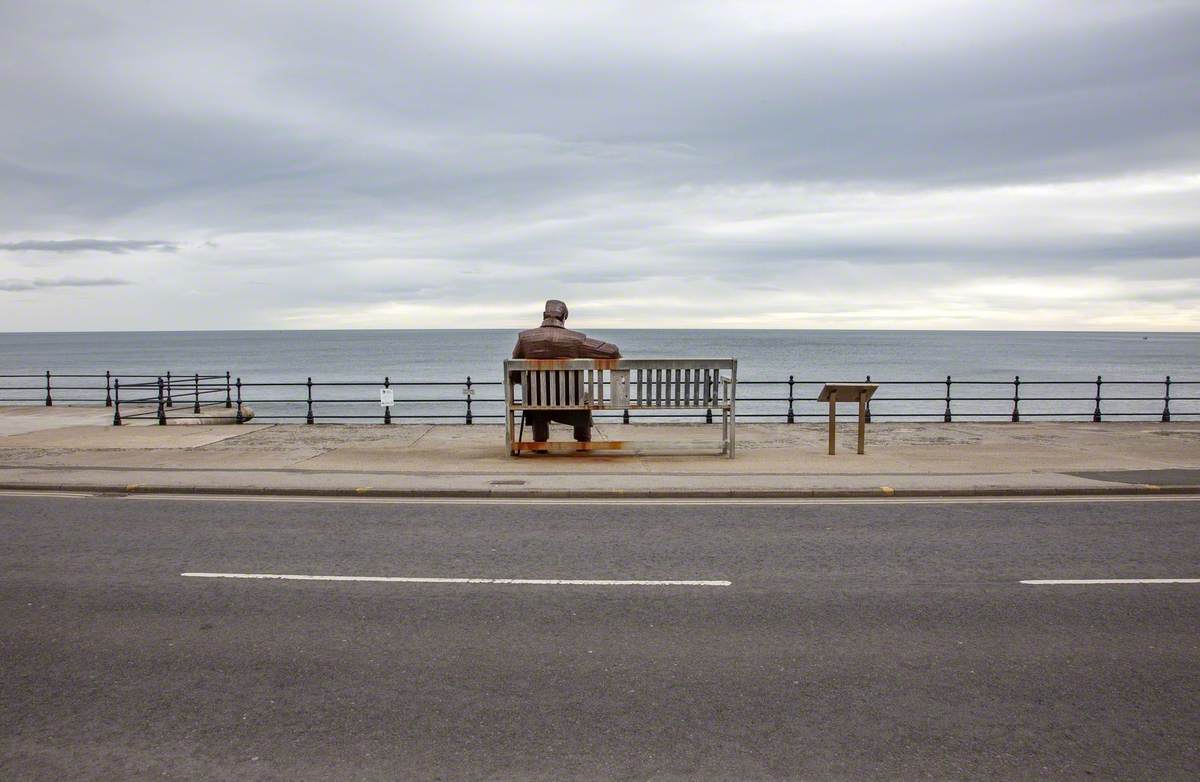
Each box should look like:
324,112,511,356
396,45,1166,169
0,2,1200,228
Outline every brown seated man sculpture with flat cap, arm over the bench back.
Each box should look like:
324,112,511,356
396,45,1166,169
512,299,620,443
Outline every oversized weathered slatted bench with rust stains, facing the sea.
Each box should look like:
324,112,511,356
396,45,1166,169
504,359,738,458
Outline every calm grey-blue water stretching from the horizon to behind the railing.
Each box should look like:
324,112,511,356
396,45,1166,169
0,329,1200,417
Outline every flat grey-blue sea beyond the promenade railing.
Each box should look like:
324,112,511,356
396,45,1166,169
0,329,1200,422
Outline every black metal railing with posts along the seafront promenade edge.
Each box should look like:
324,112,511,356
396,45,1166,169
0,371,1200,425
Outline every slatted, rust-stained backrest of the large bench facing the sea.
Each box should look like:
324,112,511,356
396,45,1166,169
504,359,738,410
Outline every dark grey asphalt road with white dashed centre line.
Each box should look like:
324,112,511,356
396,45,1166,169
0,495,1200,780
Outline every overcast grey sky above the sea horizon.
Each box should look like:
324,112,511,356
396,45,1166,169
0,0,1200,331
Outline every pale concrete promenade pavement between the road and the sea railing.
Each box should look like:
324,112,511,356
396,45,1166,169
0,407,1200,497
